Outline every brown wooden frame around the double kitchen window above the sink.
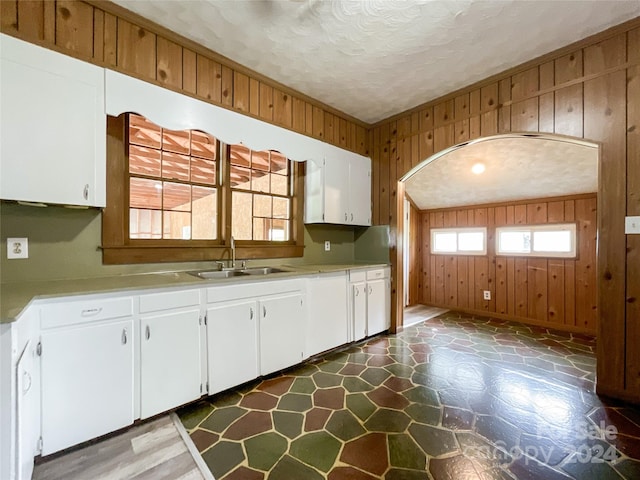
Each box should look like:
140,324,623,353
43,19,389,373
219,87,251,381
101,114,304,265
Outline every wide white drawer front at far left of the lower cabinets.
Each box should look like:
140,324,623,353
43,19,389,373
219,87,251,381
40,297,133,329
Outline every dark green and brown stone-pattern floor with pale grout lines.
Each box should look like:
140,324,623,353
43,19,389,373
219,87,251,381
179,312,640,480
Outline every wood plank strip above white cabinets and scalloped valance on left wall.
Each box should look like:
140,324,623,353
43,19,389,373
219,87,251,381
0,0,367,154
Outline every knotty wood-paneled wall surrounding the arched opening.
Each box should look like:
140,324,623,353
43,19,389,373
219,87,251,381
369,17,640,402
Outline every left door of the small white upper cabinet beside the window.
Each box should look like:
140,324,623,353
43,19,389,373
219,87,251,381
324,157,350,224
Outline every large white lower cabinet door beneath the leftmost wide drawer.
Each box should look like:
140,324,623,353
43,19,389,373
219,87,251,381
41,318,134,455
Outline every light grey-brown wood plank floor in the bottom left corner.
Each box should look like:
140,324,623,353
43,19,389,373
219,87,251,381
33,414,213,480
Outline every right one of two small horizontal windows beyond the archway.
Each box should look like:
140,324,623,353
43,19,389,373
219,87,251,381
496,223,576,258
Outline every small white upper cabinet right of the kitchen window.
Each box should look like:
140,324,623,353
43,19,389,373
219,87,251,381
304,152,371,226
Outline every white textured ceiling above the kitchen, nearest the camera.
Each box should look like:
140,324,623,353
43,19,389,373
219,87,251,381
115,0,640,123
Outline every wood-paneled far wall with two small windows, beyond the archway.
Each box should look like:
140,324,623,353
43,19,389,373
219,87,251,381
418,194,597,334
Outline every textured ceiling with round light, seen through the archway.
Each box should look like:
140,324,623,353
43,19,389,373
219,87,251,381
405,137,598,210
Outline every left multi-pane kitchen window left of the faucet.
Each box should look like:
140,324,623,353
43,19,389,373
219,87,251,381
128,114,219,240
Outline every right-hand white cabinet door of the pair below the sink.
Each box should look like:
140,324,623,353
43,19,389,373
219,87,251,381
258,293,304,375
